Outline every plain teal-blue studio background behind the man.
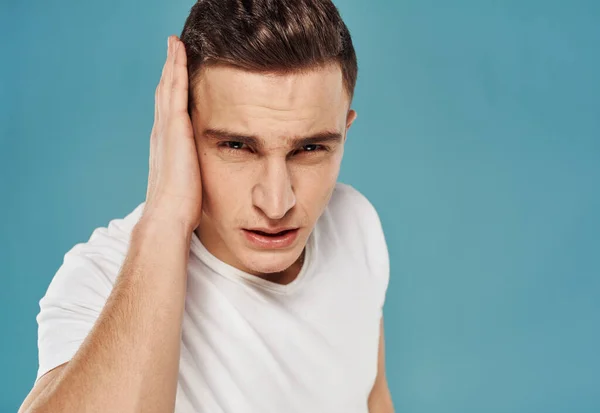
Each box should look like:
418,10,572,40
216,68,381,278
0,0,600,413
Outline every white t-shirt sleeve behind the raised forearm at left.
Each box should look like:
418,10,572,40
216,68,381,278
36,214,136,381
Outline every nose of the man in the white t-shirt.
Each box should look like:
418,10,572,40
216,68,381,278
252,159,296,220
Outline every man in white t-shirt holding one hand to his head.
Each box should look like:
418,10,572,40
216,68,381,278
20,0,393,413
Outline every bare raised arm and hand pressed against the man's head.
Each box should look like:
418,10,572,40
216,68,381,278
19,37,201,413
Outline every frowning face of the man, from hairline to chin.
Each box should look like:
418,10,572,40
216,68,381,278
192,64,356,275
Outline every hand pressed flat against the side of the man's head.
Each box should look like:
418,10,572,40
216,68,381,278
143,36,202,232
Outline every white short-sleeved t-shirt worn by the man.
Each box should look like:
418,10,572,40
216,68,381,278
37,183,389,413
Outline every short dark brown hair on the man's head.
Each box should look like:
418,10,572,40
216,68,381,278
181,0,358,106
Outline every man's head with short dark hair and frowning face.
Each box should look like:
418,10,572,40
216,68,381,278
181,0,357,275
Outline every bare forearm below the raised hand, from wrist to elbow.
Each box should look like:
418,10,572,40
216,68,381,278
30,220,191,413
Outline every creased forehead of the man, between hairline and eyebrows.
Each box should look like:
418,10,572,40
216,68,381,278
193,64,349,135
